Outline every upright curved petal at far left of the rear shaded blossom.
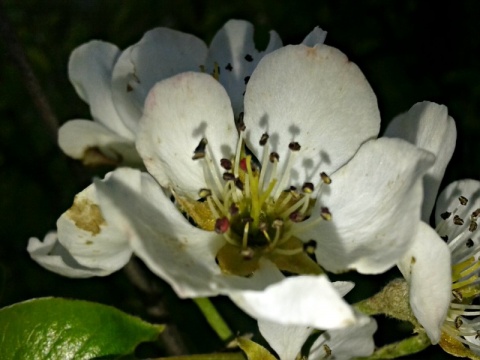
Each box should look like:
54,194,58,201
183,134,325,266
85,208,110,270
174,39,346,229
68,41,134,140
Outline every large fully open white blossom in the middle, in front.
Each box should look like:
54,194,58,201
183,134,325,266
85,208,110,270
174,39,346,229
31,45,433,328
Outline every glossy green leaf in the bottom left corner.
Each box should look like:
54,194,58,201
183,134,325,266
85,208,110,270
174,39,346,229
0,298,164,360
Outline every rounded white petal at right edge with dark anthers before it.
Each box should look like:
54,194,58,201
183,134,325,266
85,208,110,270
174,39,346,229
435,179,480,252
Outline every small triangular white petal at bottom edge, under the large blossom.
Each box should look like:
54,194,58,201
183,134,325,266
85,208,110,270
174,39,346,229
258,320,312,360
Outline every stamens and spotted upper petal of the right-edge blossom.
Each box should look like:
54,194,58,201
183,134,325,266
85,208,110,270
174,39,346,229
435,179,480,357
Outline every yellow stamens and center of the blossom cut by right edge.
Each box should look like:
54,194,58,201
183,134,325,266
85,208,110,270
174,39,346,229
436,196,480,356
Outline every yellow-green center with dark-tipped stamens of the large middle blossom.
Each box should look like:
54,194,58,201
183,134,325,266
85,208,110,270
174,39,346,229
186,114,331,276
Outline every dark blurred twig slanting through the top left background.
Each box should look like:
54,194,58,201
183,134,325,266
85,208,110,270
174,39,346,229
0,0,58,143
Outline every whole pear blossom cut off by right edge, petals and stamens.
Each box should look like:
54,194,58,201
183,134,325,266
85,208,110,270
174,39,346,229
386,102,480,358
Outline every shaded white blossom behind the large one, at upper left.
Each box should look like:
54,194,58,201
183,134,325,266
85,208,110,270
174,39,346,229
59,20,326,166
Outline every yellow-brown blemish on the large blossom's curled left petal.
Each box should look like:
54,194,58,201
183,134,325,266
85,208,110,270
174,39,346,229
66,195,105,235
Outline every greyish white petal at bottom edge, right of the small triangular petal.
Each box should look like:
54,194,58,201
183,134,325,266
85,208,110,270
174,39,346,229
308,316,377,360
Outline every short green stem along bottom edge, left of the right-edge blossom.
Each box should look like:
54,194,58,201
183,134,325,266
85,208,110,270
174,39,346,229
356,332,431,360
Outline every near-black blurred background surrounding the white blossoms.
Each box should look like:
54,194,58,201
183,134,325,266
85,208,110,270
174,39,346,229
0,0,480,359
